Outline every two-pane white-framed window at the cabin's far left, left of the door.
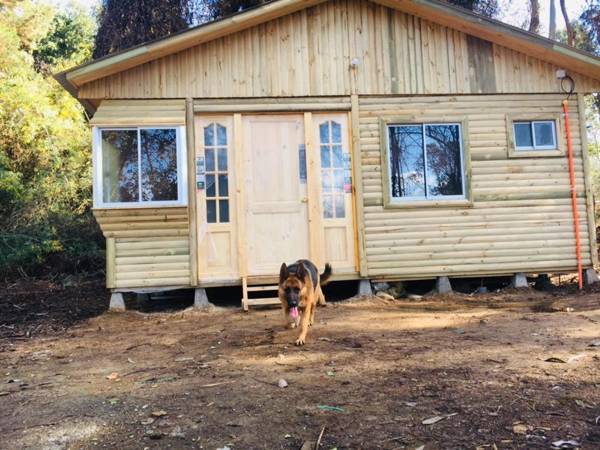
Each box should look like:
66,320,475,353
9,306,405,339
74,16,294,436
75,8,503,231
94,128,186,207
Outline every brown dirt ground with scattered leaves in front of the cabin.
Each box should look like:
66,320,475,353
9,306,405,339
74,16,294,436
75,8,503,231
0,283,600,450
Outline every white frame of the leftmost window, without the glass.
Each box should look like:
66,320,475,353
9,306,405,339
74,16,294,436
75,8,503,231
92,125,188,209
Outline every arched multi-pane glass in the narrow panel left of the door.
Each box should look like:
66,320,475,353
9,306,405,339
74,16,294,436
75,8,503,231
204,123,229,223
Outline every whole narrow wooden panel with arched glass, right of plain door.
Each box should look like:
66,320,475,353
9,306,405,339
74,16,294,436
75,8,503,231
313,114,357,273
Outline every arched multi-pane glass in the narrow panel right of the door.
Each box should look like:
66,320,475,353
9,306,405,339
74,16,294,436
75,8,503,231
319,120,346,219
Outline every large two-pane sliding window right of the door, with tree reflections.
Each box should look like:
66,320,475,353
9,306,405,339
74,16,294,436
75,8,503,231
387,123,466,203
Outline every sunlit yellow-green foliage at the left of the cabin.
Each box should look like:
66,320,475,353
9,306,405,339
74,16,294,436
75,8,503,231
0,0,102,275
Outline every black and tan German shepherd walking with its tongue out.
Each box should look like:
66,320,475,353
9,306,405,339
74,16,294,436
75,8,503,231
279,259,331,345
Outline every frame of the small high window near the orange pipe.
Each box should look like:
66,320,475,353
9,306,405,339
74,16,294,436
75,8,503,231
506,113,566,158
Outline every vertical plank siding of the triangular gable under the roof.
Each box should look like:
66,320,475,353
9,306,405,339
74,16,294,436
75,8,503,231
79,0,600,99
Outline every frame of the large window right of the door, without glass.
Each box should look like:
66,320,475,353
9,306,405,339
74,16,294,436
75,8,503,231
380,116,473,209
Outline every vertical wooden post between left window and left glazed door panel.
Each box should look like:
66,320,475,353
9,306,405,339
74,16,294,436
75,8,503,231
185,98,198,286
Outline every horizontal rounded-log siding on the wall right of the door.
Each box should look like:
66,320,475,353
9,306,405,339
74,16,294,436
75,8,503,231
360,95,591,279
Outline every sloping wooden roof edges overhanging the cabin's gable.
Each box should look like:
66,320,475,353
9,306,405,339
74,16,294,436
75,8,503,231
55,0,600,102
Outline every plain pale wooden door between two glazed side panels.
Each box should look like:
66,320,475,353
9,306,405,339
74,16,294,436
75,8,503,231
243,115,309,276
